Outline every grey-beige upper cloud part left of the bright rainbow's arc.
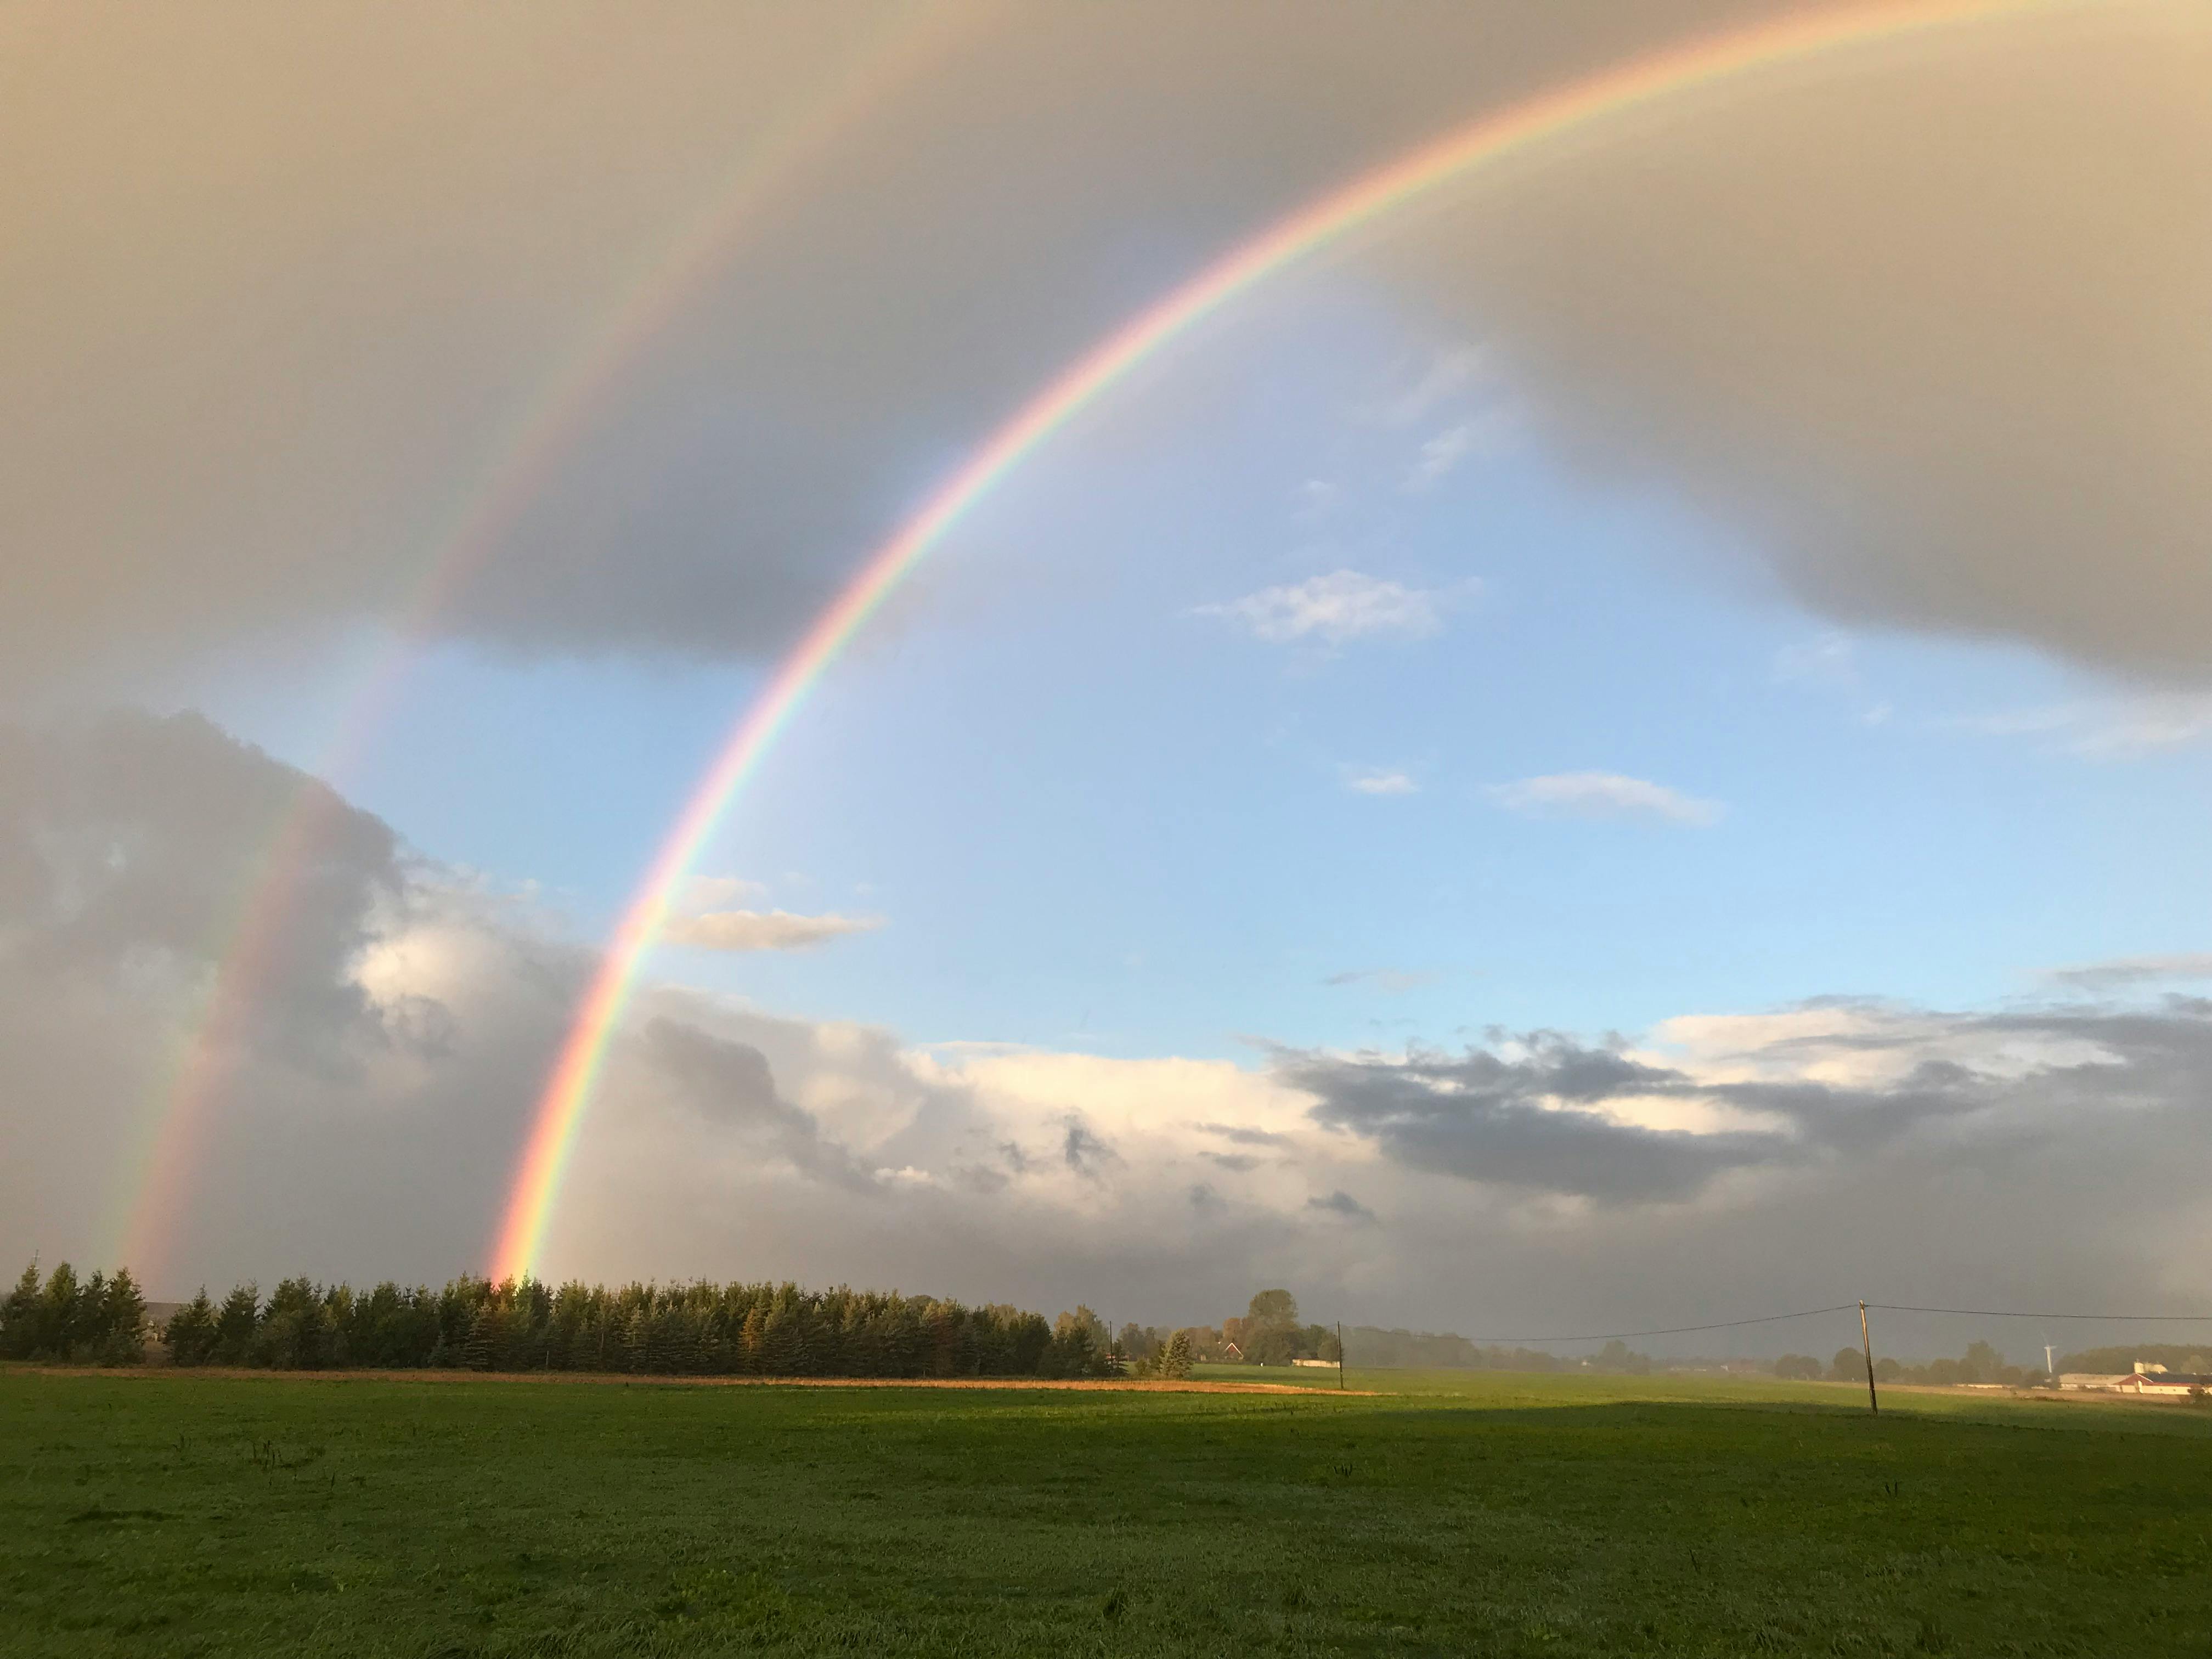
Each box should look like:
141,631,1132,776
0,0,1763,684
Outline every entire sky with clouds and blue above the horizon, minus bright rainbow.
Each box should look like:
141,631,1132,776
0,0,2212,1352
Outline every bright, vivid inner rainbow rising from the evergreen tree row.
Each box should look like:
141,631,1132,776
491,0,2052,1278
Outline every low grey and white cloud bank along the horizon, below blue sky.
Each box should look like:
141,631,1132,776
13,714,2212,1354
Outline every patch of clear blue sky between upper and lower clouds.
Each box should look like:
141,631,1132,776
172,279,2208,1055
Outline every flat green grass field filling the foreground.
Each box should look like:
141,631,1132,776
0,1367,2212,1659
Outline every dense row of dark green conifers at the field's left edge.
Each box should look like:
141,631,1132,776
0,1263,1115,1378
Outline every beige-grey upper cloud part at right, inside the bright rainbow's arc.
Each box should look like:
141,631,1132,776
1378,0,2212,686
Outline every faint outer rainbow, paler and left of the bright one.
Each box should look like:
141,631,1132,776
109,0,995,1276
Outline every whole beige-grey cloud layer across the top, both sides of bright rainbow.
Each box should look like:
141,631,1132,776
13,0,2212,703
